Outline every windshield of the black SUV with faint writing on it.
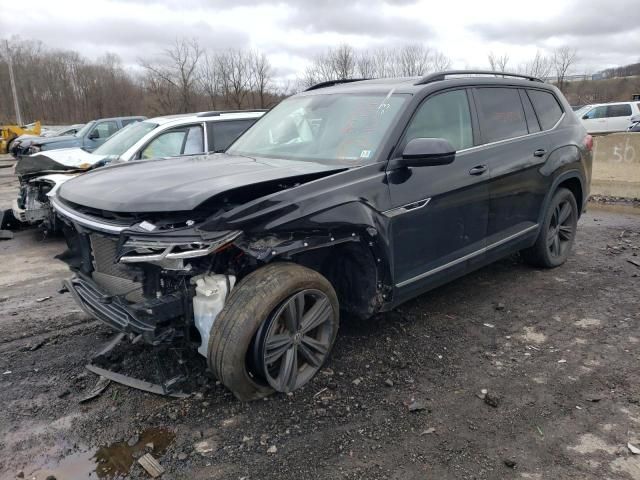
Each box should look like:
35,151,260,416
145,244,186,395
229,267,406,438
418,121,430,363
227,90,409,164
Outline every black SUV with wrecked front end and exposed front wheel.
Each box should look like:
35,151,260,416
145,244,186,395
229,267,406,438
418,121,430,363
53,71,592,400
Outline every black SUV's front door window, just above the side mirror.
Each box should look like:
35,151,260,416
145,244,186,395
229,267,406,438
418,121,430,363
404,90,472,150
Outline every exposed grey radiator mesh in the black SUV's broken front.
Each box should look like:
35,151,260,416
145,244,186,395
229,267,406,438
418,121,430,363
89,234,144,303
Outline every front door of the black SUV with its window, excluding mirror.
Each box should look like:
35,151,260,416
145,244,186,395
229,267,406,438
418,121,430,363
386,89,489,297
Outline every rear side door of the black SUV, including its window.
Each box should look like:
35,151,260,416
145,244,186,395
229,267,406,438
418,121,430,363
474,86,561,249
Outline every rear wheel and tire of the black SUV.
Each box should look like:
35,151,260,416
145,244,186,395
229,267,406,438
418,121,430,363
521,188,578,268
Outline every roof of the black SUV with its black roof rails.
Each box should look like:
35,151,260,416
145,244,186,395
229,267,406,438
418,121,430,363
303,70,553,95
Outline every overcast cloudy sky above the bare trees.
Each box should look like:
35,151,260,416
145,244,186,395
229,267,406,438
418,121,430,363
0,0,640,78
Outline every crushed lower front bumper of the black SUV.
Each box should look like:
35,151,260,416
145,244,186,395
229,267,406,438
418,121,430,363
64,275,185,343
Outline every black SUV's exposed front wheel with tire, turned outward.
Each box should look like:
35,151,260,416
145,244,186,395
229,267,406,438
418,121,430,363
208,262,339,401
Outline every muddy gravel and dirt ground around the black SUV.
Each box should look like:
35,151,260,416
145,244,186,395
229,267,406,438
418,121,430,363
0,156,640,480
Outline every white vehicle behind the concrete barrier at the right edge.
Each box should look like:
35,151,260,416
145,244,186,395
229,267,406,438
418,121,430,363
575,102,640,133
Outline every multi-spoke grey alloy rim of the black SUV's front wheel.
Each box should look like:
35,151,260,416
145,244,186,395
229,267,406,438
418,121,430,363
254,289,336,392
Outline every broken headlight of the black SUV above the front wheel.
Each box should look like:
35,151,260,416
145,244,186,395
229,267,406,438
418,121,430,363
120,230,242,263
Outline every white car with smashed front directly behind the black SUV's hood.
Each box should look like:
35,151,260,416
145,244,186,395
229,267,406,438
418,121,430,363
12,110,264,231
